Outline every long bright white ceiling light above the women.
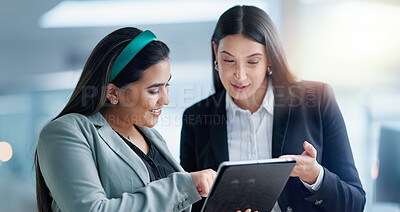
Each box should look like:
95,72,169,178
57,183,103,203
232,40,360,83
39,0,267,28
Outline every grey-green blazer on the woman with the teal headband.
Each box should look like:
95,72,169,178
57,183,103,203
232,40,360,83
37,113,201,212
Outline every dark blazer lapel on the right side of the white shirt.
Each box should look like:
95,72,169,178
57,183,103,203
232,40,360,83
272,83,292,158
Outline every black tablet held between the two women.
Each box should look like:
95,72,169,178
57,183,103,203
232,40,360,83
201,158,296,212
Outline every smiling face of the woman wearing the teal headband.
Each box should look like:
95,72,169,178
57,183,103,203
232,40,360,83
115,59,171,127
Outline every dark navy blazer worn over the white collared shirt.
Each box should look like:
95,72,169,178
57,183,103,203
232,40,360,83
180,81,365,212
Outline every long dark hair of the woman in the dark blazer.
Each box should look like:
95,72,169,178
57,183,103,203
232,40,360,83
211,5,296,92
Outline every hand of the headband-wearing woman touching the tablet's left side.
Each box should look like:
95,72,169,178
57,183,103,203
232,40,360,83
189,169,217,197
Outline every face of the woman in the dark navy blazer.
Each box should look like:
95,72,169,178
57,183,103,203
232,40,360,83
213,34,268,107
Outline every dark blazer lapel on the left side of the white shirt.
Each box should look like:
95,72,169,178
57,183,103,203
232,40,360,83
208,92,229,167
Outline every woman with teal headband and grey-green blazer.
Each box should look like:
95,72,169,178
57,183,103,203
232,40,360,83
35,28,216,212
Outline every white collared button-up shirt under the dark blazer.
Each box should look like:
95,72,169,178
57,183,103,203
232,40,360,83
225,80,324,212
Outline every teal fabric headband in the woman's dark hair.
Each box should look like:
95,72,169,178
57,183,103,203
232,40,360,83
109,30,157,82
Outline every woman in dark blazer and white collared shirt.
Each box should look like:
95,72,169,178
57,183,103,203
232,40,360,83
180,6,365,212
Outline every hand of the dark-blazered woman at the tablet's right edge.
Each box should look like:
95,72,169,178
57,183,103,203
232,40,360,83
280,141,322,185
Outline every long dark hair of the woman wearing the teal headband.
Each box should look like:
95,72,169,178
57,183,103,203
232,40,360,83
34,27,169,212
